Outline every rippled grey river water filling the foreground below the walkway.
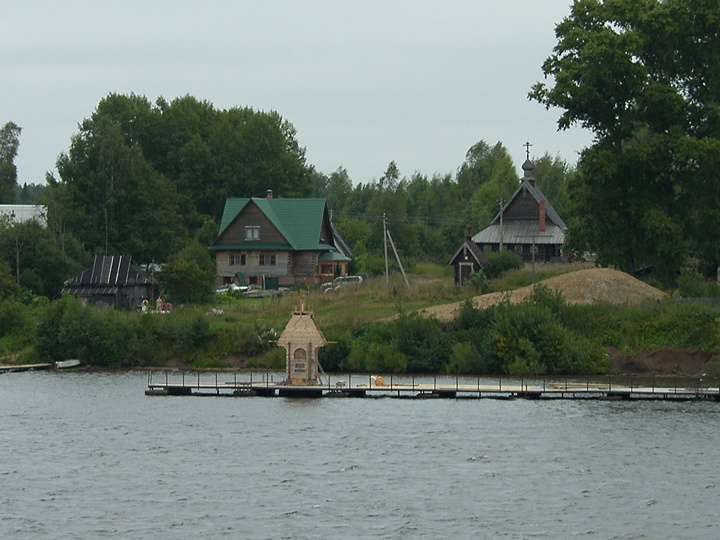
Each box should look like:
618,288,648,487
0,372,720,539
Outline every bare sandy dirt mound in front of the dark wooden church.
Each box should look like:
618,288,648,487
420,268,665,321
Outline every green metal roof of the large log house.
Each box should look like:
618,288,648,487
213,197,325,251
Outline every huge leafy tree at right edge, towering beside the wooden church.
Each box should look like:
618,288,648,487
530,0,720,283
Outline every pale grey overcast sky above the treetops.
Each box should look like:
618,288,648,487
0,0,592,188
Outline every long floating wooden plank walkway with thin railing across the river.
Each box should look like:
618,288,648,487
145,372,720,401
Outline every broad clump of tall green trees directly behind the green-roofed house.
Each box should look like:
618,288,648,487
58,94,315,262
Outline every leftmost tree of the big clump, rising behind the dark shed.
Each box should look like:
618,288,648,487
53,107,187,262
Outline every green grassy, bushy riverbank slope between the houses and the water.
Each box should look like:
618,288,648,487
0,265,720,375
